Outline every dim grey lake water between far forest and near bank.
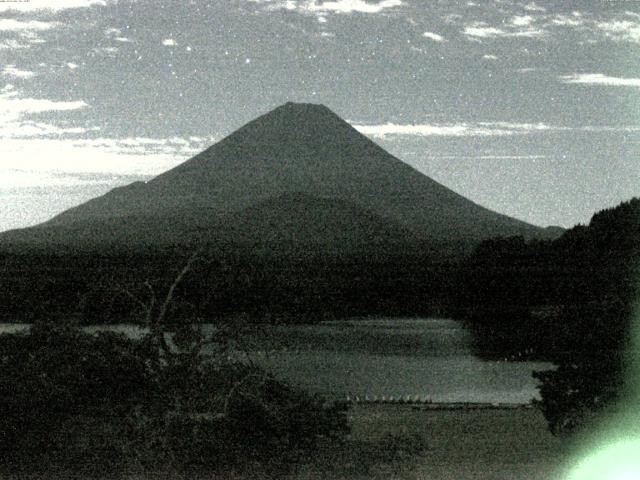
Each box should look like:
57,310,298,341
0,318,552,403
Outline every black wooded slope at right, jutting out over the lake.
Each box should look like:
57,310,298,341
461,199,640,433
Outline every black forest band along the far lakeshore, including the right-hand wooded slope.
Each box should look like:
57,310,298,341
0,199,640,438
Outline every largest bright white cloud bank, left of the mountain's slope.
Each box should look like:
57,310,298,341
0,85,217,172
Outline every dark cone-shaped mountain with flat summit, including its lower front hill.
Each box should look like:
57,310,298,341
0,103,556,248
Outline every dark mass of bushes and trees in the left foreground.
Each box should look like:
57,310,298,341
0,316,348,476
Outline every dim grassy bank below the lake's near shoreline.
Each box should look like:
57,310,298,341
2,405,568,480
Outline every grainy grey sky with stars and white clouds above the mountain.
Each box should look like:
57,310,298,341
0,0,640,231
